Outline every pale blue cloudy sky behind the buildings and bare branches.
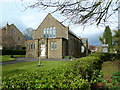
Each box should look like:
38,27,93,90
0,0,118,46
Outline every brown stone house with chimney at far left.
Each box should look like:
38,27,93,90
0,23,25,49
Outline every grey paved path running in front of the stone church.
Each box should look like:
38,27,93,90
0,58,71,65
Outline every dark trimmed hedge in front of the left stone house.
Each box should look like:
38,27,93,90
2,50,26,55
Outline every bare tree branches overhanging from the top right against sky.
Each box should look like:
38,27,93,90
23,0,119,25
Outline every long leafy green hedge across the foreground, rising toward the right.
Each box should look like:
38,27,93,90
2,53,102,90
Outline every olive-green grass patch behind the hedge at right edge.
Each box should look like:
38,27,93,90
102,60,120,77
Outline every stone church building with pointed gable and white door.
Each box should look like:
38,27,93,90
26,14,88,59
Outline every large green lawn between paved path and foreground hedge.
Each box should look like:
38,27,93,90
2,61,69,77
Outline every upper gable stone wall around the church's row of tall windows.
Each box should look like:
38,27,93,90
33,14,69,39
